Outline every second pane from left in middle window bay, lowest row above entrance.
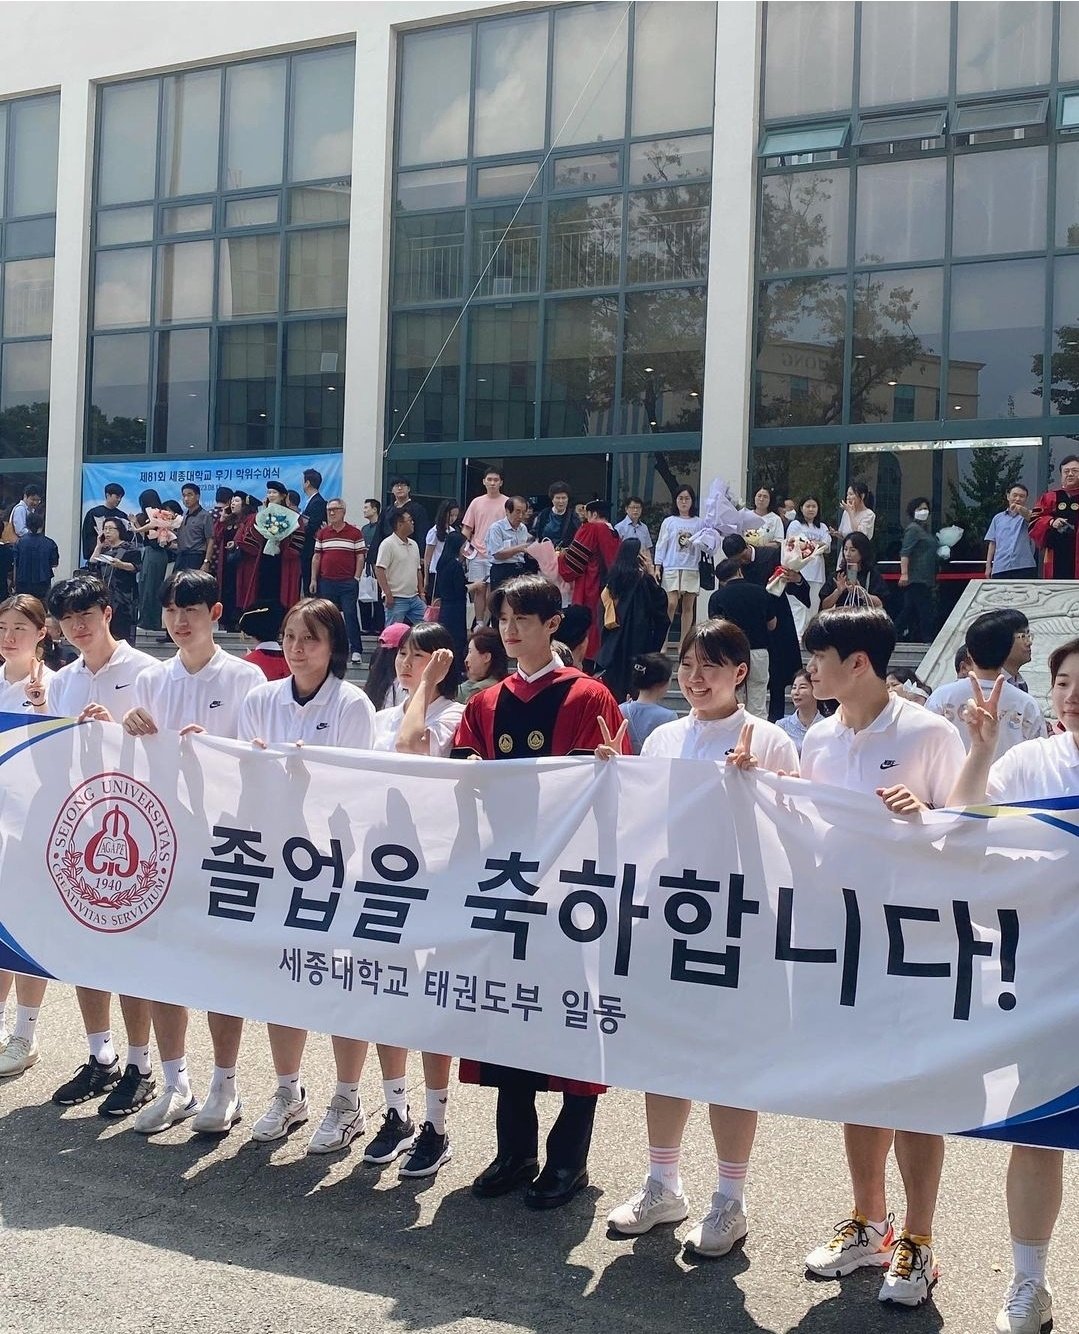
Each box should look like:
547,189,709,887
464,303,539,440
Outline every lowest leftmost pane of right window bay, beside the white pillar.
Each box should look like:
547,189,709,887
755,277,847,426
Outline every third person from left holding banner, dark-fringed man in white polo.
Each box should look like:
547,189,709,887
124,570,265,1135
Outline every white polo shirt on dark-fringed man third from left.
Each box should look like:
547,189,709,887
129,648,265,739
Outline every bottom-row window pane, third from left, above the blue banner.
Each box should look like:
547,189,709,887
215,324,277,454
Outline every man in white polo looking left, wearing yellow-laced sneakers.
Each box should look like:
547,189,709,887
802,607,964,1306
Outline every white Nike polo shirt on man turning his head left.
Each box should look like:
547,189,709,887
802,695,966,806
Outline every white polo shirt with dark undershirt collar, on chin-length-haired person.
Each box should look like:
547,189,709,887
237,675,375,750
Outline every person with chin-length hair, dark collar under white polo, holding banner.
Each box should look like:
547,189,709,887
240,598,375,1154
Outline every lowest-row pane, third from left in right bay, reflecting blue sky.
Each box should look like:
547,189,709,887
948,260,1046,420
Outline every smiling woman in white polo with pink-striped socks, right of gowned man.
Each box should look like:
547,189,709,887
596,619,798,1258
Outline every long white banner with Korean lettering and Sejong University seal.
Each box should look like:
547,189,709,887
0,715,1079,1146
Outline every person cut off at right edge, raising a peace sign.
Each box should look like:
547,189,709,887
951,639,1079,1334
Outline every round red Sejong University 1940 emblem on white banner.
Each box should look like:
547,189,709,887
45,774,176,931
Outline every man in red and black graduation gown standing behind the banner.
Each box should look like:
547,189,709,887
455,575,628,1209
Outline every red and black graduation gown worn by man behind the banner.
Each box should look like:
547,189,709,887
453,667,632,1097
